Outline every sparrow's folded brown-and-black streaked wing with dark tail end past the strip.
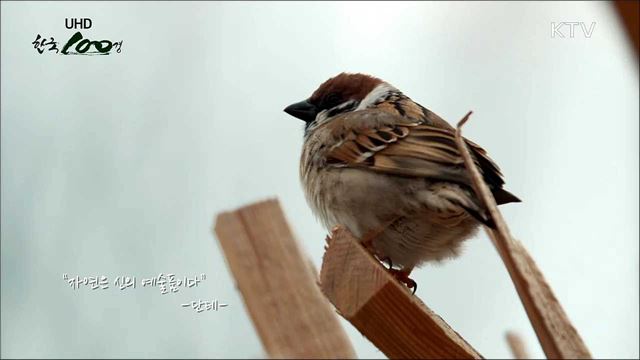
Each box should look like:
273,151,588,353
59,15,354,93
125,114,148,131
326,111,519,203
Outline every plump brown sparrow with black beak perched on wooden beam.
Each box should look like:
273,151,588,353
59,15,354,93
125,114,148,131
284,72,521,293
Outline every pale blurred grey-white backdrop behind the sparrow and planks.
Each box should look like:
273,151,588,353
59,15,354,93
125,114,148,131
0,2,640,358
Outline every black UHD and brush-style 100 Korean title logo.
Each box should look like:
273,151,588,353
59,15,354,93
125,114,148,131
31,18,123,55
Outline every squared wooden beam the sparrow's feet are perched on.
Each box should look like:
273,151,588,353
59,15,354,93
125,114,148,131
320,227,482,359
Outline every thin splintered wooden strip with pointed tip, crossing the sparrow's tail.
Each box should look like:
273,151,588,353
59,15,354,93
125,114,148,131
456,112,591,359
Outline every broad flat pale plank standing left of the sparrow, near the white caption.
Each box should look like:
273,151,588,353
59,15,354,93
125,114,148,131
215,200,355,358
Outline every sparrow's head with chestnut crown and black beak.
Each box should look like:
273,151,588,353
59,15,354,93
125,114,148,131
284,73,400,128
